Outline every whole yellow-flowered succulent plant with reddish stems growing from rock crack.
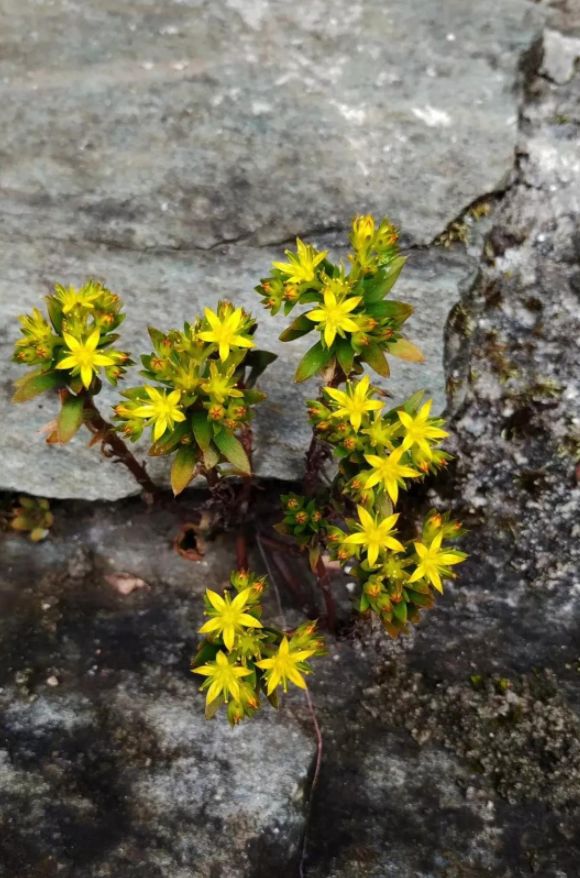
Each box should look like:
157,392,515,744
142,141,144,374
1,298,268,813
14,216,466,723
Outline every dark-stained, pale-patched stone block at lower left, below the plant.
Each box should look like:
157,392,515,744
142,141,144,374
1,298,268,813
0,503,314,878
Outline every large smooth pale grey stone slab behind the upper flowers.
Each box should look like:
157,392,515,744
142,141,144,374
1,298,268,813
0,0,540,500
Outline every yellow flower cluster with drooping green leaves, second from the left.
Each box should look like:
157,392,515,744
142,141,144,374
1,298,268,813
115,301,274,494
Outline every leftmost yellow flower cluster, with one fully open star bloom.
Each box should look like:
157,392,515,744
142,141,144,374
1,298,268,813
14,280,130,402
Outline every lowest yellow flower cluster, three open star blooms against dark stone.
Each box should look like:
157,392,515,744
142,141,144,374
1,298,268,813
192,571,325,725
